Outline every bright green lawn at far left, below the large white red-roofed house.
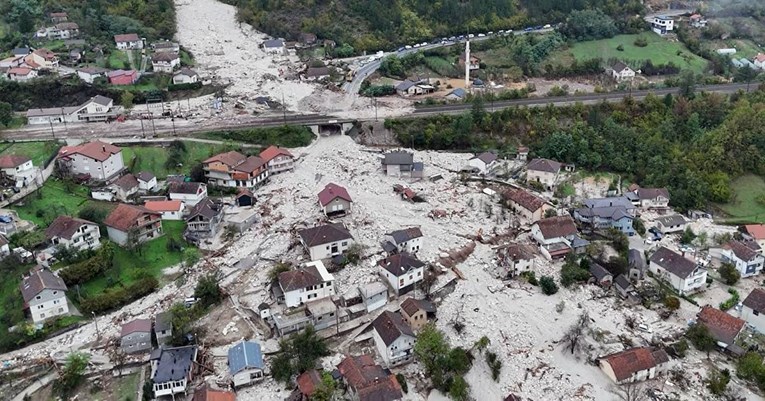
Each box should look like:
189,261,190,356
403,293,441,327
12,179,115,227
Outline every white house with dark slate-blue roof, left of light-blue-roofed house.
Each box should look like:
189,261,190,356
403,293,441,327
149,345,198,399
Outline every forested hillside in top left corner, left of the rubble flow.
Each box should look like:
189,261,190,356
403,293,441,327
0,0,175,49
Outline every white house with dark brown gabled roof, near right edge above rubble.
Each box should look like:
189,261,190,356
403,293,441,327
648,247,707,294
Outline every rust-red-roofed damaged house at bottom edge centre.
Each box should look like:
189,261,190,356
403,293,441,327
337,354,403,401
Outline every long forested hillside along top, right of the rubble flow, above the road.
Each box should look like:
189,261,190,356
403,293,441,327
224,0,643,50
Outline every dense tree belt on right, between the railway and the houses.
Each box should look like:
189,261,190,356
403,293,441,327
386,89,765,209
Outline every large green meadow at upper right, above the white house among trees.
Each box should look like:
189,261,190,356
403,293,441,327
564,33,707,73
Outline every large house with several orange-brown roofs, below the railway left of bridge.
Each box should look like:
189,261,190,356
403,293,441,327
202,151,269,188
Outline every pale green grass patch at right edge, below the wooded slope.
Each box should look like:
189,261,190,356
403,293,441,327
718,175,765,223
